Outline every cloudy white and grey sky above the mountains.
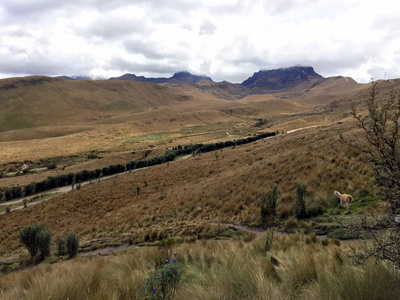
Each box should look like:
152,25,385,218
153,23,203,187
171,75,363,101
0,0,400,83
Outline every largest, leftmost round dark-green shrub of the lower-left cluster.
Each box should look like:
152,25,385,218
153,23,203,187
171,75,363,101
19,224,51,259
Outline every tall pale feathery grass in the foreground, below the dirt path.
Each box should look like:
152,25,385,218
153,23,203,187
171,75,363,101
0,234,400,300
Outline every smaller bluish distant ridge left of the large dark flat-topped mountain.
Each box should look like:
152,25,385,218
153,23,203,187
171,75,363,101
109,71,213,84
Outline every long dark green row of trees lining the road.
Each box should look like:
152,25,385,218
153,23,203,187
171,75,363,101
0,132,276,201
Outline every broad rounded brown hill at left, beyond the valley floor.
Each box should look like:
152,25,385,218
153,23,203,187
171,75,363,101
0,77,190,132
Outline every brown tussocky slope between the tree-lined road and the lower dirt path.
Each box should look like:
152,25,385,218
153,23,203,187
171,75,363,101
0,120,375,255
